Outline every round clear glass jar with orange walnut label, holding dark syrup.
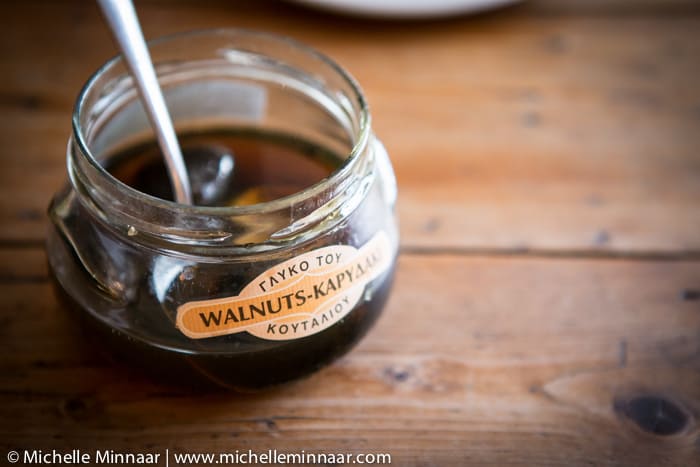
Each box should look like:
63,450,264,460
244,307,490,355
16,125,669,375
47,29,398,389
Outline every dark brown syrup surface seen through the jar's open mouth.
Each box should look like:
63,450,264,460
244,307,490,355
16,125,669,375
106,131,343,206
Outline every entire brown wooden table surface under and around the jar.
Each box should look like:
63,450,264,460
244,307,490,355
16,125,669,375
0,0,700,466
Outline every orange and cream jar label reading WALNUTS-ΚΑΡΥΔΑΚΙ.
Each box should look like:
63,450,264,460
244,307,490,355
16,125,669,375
177,232,393,340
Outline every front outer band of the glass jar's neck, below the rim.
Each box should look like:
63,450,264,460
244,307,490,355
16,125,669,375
68,130,375,254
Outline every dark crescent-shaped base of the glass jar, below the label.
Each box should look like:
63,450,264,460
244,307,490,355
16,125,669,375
50,268,394,393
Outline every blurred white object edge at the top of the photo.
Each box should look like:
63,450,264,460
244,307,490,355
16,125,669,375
293,0,522,19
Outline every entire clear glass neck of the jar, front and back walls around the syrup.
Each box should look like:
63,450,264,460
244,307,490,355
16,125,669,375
68,30,374,254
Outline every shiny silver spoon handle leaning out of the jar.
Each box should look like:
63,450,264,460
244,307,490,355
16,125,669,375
98,0,192,204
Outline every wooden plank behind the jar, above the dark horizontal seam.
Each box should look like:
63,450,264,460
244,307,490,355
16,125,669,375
0,2,700,254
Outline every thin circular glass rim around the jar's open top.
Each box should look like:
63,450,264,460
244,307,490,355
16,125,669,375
72,28,371,216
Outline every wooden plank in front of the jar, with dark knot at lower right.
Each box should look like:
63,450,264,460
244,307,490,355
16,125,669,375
0,250,700,466
